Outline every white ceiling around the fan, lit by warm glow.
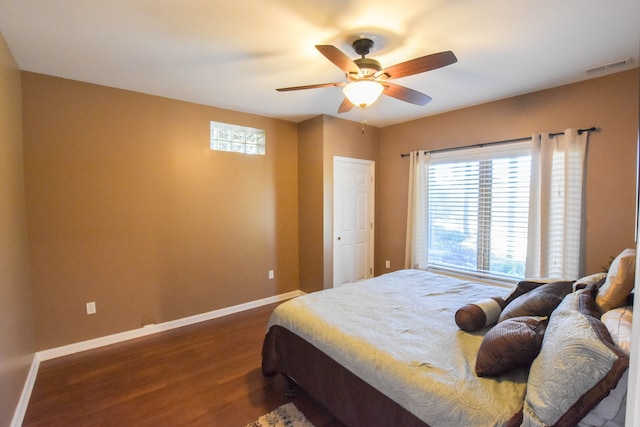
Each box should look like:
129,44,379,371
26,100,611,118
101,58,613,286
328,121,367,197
0,0,640,126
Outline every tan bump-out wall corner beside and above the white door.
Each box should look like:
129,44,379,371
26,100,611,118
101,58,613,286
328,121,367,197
298,116,380,292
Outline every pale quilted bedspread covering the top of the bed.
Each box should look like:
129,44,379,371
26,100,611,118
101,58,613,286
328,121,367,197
268,270,527,426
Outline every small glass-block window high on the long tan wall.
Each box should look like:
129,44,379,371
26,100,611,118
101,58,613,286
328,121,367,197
210,122,266,155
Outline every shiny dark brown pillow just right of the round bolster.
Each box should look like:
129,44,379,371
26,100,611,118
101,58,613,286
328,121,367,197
498,282,573,322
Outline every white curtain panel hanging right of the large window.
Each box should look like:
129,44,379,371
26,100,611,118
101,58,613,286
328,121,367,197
526,129,589,279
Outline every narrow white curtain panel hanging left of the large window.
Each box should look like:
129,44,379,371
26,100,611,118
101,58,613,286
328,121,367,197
404,151,431,270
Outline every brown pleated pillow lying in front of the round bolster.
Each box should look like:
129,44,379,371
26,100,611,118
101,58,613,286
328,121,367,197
476,317,548,377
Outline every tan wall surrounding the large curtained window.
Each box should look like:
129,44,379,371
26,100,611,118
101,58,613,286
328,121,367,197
376,69,638,274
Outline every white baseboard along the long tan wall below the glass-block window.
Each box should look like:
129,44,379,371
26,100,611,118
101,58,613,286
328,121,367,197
36,291,304,362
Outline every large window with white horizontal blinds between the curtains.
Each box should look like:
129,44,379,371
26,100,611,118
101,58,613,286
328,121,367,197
425,142,531,278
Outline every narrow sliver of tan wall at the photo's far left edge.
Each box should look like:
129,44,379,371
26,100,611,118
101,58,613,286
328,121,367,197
0,30,35,426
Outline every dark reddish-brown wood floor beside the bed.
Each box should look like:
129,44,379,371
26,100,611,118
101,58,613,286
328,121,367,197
23,305,343,427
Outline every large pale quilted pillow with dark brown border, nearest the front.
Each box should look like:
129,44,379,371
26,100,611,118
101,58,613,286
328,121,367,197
522,293,629,426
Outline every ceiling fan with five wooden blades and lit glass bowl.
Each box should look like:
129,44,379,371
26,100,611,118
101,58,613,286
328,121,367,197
276,38,458,113
